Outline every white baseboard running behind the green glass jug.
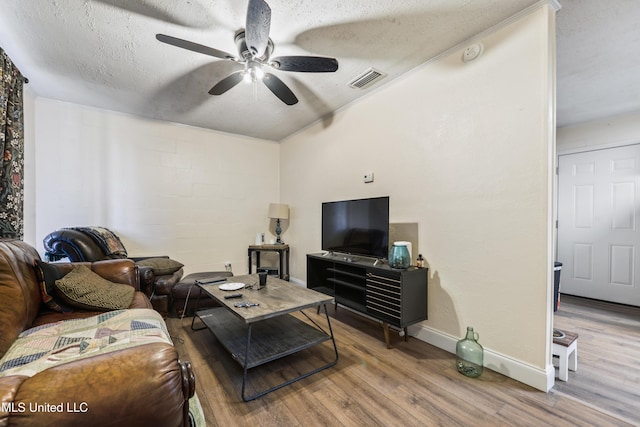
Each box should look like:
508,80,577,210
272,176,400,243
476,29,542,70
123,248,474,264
408,325,555,392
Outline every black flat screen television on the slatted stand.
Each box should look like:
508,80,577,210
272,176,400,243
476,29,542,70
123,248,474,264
322,196,389,259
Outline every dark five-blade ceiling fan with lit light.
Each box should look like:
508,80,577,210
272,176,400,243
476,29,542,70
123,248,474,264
156,0,338,105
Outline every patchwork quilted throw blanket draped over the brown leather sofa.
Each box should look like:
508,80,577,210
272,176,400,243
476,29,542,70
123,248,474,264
0,308,172,377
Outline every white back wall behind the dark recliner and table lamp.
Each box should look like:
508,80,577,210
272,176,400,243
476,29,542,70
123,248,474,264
35,98,279,274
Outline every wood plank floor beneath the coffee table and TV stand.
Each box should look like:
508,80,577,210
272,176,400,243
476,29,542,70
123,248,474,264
167,298,640,427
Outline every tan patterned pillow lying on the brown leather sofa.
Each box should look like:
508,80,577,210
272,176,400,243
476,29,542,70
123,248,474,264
56,265,135,311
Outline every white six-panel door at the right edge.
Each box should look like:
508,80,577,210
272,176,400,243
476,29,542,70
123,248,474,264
558,145,640,306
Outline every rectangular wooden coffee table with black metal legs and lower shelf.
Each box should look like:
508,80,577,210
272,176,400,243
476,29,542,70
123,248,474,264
191,274,338,402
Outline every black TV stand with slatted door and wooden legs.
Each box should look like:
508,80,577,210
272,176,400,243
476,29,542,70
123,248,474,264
307,254,427,348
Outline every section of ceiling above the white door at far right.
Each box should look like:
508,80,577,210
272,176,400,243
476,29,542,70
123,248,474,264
556,0,640,127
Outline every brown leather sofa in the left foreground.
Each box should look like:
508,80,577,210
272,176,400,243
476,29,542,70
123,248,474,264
0,239,195,427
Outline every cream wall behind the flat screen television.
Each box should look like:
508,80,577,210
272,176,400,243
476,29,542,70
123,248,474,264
281,6,555,389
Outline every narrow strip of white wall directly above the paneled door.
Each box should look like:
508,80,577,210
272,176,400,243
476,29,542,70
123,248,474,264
557,111,640,153
